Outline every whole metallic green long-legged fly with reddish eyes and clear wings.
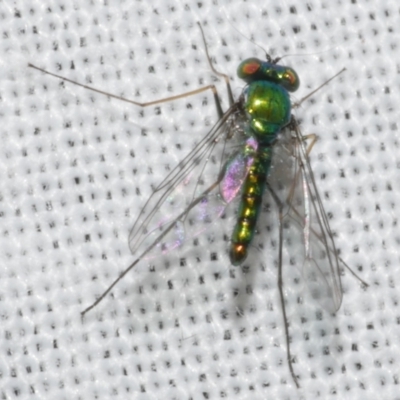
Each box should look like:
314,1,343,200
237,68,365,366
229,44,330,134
29,23,360,387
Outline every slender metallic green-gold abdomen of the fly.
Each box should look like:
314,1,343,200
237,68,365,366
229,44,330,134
229,146,271,265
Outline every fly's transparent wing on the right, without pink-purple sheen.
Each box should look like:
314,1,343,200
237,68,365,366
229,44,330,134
269,121,343,312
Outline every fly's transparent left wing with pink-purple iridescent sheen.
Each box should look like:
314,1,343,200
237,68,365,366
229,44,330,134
129,105,250,258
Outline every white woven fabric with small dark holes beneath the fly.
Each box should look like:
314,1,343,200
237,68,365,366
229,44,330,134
0,0,400,400
